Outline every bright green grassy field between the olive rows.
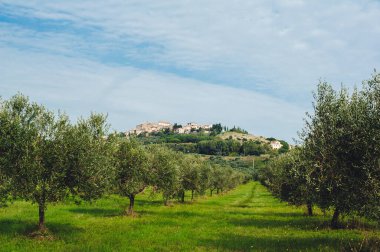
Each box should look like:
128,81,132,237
0,182,380,251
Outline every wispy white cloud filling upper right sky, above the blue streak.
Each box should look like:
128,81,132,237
2,0,380,97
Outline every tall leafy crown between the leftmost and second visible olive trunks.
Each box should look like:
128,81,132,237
66,114,116,203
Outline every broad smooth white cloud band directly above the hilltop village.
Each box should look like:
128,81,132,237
0,48,304,140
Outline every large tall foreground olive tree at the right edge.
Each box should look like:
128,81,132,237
301,78,380,227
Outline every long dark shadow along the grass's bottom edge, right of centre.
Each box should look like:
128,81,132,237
199,233,354,251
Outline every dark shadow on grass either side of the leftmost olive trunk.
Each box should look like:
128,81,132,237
0,219,83,237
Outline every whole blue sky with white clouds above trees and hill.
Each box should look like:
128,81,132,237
0,0,380,143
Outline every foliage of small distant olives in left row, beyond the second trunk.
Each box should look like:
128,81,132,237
148,145,244,205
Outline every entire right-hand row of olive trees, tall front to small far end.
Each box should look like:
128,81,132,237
262,74,380,227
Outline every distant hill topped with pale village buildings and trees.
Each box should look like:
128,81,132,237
126,121,290,157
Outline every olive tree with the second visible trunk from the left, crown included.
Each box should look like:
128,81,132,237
116,140,150,215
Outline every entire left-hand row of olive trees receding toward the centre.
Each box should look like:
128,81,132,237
0,94,244,231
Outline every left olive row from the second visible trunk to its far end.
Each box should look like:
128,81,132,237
115,139,244,214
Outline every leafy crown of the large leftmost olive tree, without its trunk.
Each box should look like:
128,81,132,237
0,95,69,205
